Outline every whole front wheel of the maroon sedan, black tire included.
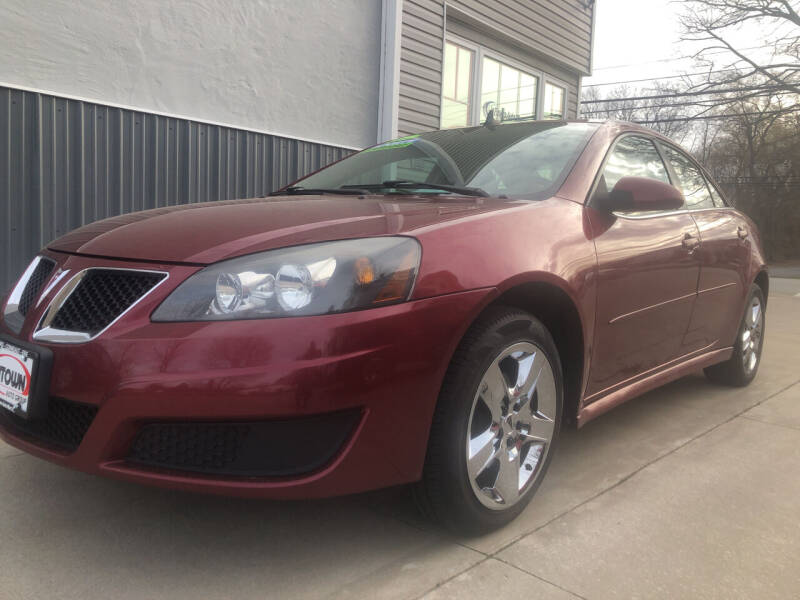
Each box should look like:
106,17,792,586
415,307,563,533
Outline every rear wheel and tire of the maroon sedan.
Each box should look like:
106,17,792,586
704,283,766,387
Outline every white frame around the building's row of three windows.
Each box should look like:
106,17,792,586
439,34,570,129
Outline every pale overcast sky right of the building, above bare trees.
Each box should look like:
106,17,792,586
583,0,788,91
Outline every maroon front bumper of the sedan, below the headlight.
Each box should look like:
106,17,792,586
0,253,491,498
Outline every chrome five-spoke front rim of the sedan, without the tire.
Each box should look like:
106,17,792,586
466,342,558,510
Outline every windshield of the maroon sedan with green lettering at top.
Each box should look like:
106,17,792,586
294,121,598,200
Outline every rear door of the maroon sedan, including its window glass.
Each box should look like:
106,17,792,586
662,144,750,352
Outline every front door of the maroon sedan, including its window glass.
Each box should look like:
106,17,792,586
586,134,699,402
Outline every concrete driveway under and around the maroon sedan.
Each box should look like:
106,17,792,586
0,281,800,600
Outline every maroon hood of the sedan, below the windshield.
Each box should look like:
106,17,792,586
48,196,520,264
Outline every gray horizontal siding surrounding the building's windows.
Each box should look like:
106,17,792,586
398,0,594,134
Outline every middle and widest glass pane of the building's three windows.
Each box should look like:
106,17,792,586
481,57,539,120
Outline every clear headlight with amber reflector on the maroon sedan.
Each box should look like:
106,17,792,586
152,237,420,322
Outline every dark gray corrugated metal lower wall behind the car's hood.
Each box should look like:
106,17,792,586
0,87,351,294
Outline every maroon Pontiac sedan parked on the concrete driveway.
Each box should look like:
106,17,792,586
0,121,769,530
